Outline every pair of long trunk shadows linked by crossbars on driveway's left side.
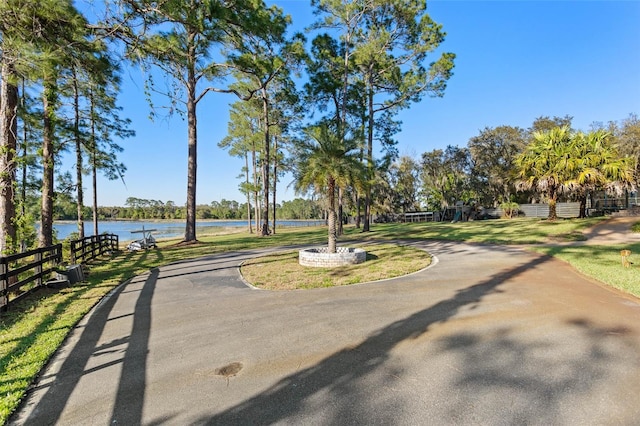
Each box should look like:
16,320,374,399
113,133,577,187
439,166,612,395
10,269,159,424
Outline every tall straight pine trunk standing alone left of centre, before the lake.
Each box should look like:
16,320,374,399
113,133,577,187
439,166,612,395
184,52,198,242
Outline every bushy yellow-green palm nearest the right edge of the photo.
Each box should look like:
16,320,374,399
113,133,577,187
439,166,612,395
568,129,634,217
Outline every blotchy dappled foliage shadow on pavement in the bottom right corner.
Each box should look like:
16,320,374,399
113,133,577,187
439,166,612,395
432,319,640,424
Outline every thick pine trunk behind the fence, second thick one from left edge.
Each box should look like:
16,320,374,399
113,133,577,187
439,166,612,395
39,70,57,247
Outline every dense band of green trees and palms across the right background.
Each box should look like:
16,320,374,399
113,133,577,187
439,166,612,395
378,114,640,220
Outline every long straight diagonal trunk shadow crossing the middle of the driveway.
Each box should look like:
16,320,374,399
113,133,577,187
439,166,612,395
197,251,549,425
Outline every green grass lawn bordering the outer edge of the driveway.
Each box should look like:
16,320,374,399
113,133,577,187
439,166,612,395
0,218,640,424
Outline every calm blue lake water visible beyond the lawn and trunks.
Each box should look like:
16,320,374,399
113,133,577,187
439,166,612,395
53,220,325,242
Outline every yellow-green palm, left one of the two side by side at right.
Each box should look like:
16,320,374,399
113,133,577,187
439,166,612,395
516,126,577,220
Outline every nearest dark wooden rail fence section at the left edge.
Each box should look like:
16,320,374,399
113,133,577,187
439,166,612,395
0,244,62,311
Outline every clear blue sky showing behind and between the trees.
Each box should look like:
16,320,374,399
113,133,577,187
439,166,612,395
75,0,640,206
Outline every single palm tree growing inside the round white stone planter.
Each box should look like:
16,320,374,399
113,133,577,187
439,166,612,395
295,123,364,253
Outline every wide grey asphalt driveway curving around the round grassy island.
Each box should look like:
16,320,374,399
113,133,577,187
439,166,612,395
12,231,640,425
